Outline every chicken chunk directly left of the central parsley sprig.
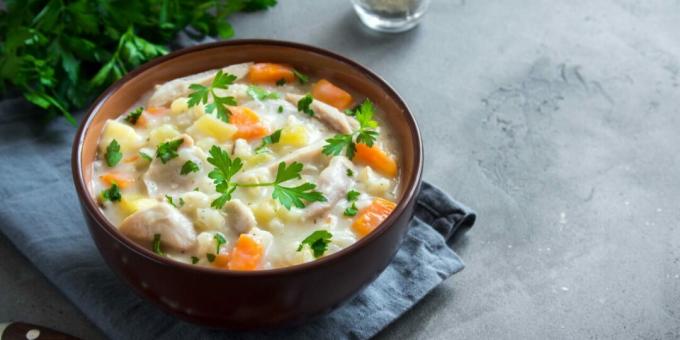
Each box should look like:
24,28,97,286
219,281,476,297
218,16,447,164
144,146,208,197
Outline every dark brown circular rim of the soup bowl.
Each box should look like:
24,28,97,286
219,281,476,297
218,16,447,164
71,39,423,277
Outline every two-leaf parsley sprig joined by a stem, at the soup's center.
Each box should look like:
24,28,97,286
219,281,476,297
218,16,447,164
208,145,326,210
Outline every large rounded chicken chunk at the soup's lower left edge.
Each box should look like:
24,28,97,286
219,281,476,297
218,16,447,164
118,203,196,250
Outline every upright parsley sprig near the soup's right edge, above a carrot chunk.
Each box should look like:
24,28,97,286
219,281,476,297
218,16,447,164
322,98,378,159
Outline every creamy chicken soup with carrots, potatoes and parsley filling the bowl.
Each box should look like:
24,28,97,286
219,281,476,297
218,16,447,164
92,63,399,270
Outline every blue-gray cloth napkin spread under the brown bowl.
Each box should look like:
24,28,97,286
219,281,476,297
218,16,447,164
0,99,475,339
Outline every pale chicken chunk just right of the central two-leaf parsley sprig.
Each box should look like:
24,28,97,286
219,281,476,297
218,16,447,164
305,156,354,218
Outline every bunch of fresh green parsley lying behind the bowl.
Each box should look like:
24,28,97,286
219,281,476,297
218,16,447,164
0,0,276,124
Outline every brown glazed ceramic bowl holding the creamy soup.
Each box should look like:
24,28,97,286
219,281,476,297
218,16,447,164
71,40,423,329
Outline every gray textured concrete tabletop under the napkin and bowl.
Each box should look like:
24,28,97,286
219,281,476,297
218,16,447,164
0,0,680,339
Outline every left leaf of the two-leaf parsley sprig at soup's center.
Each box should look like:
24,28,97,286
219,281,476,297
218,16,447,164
208,145,243,209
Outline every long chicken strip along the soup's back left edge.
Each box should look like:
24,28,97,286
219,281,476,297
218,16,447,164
146,63,252,107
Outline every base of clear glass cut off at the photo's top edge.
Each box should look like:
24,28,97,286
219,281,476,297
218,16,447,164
352,0,430,32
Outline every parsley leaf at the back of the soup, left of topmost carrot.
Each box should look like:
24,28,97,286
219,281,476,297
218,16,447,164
187,70,237,123
